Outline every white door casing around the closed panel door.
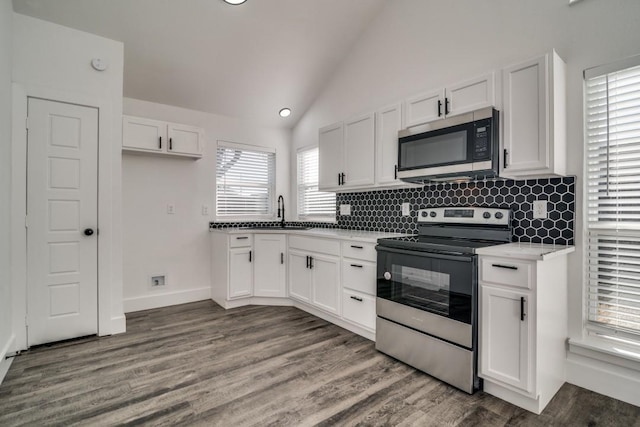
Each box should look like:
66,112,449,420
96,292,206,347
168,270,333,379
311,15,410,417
11,82,124,351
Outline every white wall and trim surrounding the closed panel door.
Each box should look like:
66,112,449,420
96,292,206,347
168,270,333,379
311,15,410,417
11,13,125,349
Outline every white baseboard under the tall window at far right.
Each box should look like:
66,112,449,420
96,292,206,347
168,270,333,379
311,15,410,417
567,352,640,406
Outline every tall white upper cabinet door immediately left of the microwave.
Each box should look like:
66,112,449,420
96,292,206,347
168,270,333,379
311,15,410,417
376,104,402,184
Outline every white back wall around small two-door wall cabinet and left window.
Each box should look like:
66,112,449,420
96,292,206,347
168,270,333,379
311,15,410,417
122,98,291,312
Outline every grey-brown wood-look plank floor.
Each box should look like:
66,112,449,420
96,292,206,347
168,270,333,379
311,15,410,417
0,301,640,426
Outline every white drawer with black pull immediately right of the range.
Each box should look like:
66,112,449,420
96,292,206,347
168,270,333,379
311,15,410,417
480,257,535,289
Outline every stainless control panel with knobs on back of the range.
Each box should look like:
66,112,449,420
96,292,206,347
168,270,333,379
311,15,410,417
418,207,511,225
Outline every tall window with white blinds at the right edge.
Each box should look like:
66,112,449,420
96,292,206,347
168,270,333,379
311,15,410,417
585,57,640,342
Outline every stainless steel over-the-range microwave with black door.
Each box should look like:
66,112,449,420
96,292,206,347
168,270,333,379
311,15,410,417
398,107,499,183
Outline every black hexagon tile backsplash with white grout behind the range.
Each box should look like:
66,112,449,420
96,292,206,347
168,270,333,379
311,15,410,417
336,176,575,245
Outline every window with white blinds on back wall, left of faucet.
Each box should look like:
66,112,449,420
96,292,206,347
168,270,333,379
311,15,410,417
216,141,276,220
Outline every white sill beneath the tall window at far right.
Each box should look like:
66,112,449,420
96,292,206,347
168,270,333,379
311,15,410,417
569,337,640,371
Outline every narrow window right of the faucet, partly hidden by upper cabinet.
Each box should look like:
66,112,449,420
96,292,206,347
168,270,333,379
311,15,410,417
298,147,336,220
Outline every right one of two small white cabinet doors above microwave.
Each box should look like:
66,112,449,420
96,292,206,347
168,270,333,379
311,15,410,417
445,73,496,116
